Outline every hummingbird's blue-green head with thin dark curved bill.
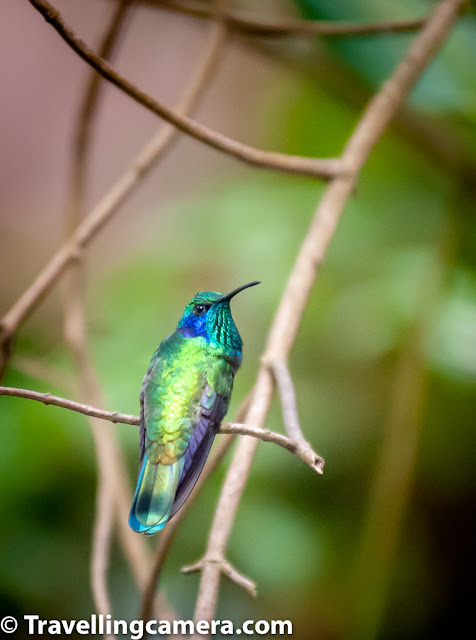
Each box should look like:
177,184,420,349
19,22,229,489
177,282,259,355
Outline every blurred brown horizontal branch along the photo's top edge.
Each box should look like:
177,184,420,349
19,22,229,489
142,0,426,38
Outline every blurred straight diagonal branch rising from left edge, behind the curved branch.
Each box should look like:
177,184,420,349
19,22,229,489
0,10,224,380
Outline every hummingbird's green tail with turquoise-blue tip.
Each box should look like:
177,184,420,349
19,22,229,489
129,455,183,535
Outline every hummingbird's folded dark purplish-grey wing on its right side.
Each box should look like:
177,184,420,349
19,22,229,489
170,385,228,517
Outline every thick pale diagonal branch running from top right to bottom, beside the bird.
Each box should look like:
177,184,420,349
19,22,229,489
190,0,464,632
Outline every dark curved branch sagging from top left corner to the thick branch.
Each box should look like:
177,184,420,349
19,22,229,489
28,0,344,180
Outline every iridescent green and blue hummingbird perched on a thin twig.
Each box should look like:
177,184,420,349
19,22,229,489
129,282,259,535
